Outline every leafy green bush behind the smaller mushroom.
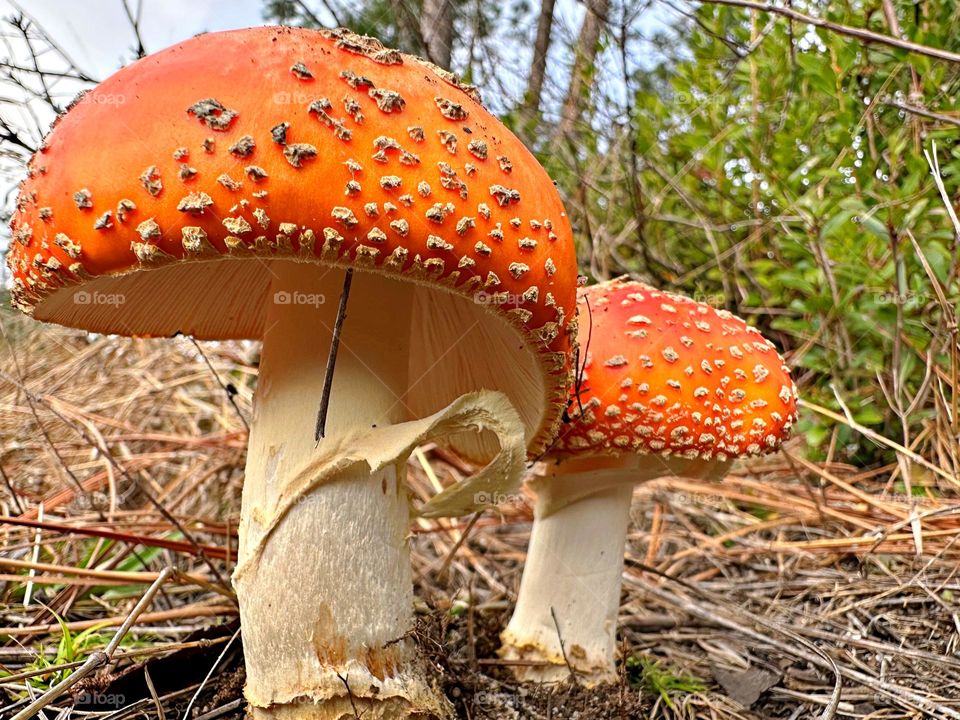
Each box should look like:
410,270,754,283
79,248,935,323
544,0,960,463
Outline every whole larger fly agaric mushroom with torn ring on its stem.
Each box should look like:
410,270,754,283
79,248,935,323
8,28,576,719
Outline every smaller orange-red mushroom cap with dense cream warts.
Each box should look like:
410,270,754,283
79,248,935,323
552,279,797,461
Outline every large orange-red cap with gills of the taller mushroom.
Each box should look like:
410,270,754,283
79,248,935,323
8,27,576,462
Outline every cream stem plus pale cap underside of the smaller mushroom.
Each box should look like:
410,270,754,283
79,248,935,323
500,456,729,685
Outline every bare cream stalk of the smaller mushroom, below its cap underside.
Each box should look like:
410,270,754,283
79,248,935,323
501,483,633,685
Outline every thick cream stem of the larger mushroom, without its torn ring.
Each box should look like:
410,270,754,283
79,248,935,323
234,262,445,720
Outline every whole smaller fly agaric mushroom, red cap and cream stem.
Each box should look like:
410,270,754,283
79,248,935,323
501,279,797,684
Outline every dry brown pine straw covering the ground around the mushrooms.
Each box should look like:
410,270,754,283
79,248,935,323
0,311,960,720
